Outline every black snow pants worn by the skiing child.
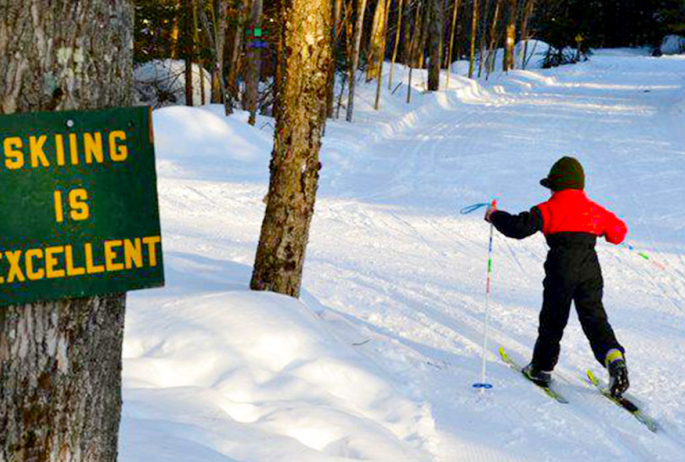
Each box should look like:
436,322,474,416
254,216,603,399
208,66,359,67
533,233,624,371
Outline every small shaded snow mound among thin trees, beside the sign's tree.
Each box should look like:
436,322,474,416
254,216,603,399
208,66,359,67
133,59,212,107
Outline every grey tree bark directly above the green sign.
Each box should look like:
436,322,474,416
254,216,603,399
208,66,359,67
0,0,133,114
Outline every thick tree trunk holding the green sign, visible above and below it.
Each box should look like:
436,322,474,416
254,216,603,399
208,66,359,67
0,0,133,462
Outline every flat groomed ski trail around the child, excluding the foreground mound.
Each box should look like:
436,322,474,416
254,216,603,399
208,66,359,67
125,51,685,462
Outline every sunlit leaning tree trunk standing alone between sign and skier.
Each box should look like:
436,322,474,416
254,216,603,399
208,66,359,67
250,0,333,297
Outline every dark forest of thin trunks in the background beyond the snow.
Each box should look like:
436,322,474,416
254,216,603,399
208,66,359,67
134,0,685,117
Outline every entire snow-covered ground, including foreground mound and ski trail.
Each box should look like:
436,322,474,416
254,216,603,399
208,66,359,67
120,50,685,462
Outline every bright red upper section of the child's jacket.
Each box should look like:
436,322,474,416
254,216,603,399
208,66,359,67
537,189,628,244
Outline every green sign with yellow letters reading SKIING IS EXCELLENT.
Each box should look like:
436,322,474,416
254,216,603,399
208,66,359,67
0,108,164,306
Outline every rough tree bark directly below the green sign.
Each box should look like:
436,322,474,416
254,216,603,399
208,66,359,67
0,295,125,462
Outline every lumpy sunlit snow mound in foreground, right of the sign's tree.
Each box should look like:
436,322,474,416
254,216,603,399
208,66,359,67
120,291,434,462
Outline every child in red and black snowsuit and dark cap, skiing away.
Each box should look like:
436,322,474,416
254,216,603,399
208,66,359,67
485,157,629,397
